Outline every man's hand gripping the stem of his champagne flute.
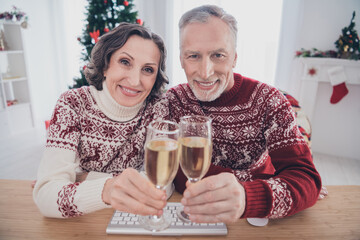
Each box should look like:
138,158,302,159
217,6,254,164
181,173,245,223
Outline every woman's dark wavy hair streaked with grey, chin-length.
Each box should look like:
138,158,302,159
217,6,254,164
85,22,169,98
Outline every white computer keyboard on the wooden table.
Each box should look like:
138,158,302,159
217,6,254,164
106,202,227,236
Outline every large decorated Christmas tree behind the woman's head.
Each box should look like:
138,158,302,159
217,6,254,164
69,0,143,88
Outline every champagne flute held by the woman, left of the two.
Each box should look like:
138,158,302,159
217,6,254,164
139,120,179,232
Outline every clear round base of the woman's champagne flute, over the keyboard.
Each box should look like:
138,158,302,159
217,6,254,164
139,212,172,232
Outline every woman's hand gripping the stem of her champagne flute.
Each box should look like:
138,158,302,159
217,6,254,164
102,168,166,216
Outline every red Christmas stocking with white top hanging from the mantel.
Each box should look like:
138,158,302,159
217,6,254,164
328,66,349,104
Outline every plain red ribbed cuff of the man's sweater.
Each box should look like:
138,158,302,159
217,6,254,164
241,180,272,218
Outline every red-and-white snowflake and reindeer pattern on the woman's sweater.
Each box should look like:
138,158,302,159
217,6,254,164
46,87,168,217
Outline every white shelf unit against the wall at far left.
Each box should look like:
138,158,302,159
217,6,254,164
0,20,34,134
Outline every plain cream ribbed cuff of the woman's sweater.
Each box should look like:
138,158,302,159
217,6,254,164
75,176,111,213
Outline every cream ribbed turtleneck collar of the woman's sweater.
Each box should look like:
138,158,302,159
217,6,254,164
90,81,144,122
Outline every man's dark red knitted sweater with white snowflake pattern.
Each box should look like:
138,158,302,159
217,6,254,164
167,74,321,218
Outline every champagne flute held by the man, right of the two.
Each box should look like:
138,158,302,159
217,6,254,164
177,115,212,223
